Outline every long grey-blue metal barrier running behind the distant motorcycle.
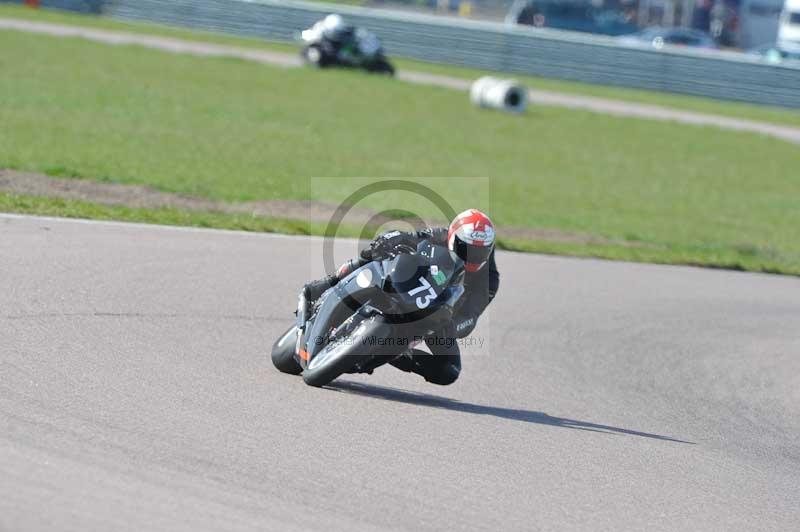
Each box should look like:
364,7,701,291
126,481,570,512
6,0,800,108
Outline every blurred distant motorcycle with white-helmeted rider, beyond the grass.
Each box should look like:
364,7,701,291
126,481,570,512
300,15,394,75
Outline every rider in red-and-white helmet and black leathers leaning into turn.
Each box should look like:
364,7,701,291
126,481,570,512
303,209,500,385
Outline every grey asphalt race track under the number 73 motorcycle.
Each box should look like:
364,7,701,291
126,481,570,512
0,215,800,532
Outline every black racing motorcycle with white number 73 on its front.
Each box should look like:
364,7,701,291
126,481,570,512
272,241,464,386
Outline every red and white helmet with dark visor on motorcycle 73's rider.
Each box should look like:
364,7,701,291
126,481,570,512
447,209,494,272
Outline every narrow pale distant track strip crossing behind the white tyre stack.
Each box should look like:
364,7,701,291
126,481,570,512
0,18,800,144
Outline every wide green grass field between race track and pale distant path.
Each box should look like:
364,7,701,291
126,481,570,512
0,17,800,274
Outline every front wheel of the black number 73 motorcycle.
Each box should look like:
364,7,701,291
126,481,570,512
303,317,392,387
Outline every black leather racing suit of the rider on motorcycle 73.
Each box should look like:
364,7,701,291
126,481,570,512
305,227,500,385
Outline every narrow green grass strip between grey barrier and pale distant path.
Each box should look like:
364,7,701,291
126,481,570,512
0,5,800,127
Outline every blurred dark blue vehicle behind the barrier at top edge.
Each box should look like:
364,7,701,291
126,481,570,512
506,0,636,35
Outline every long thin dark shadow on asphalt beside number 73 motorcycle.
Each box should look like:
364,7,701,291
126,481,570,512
327,380,694,445
